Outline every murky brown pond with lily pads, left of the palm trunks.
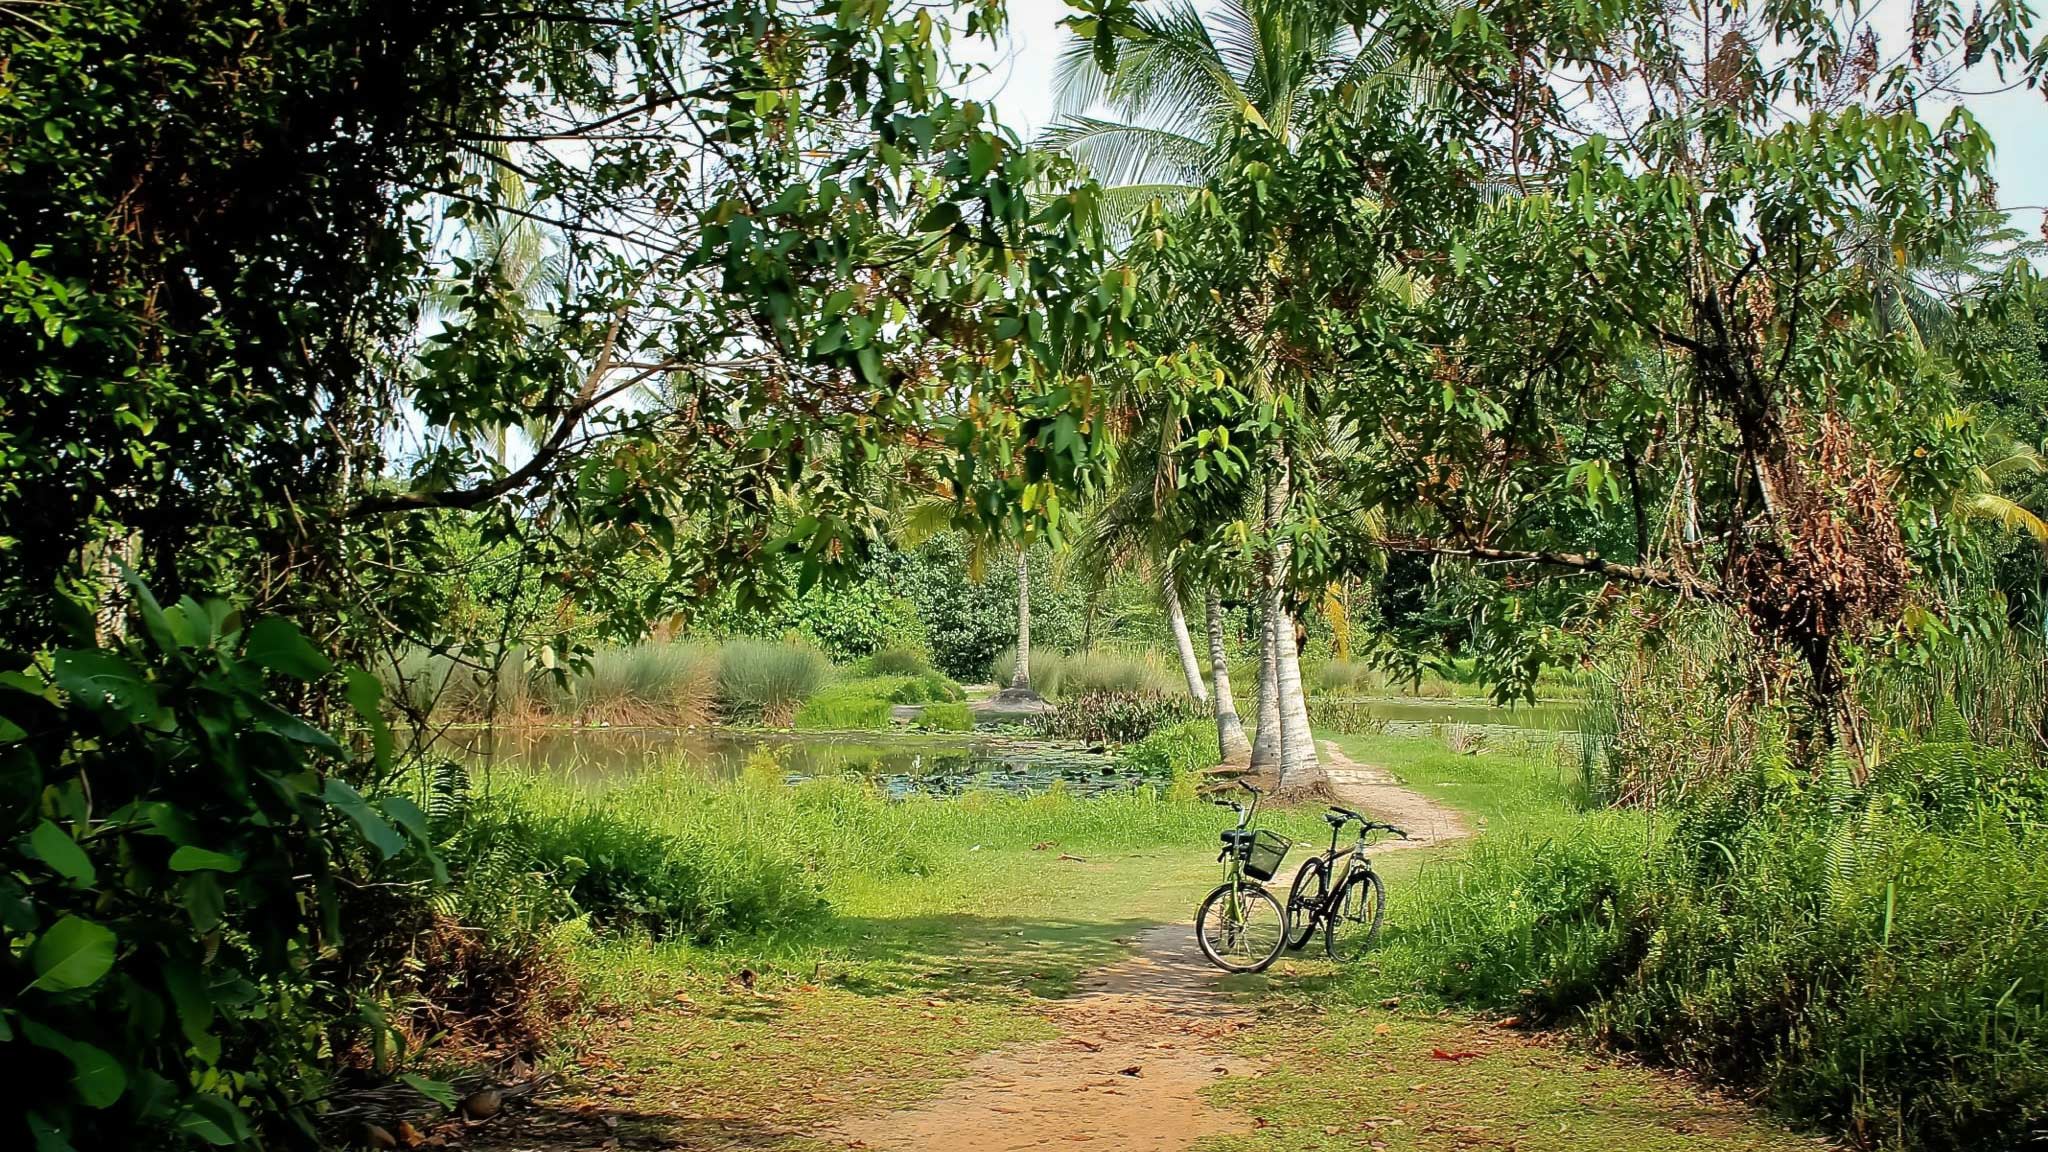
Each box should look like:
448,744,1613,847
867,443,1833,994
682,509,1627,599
442,728,1147,797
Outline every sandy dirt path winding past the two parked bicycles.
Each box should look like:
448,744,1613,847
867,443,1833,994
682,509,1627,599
819,742,1468,1152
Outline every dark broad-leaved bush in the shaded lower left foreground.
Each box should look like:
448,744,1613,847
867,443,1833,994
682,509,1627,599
0,586,430,1150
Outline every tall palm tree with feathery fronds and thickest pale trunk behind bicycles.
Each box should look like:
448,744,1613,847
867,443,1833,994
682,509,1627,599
1044,0,1411,791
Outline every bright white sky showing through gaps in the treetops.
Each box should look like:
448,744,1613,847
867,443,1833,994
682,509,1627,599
958,0,2048,236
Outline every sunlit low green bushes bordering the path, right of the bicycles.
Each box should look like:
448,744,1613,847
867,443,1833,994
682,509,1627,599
1389,754,2048,1148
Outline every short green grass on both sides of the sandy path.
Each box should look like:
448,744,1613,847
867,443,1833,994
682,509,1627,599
456,726,1818,1152
